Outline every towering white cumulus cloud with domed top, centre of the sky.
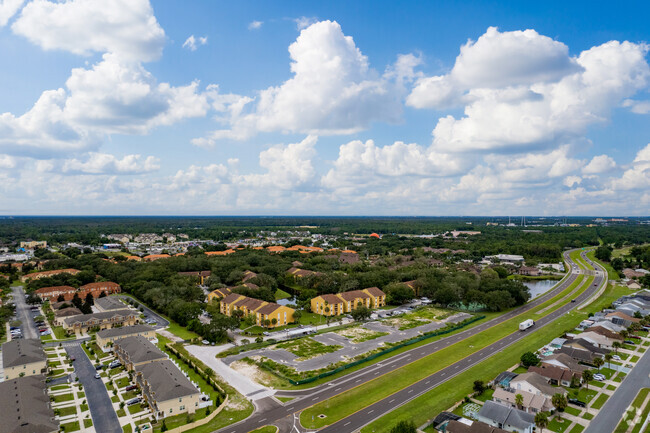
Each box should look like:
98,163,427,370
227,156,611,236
196,21,417,140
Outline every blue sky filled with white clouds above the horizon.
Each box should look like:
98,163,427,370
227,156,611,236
0,0,650,215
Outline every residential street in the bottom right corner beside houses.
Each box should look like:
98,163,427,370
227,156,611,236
585,338,650,433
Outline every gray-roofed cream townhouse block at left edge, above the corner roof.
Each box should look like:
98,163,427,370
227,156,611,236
0,339,47,378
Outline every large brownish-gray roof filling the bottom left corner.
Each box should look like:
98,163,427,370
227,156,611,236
0,375,59,433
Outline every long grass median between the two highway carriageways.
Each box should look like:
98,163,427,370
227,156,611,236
301,275,593,428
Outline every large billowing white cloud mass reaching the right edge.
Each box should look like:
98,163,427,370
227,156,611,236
407,28,650,152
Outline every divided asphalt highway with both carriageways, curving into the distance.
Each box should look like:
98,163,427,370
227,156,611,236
219,252,604,433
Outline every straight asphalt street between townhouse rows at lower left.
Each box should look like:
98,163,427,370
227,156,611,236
64,343,122,433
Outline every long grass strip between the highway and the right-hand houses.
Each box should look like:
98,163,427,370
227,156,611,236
356,276,611,433
